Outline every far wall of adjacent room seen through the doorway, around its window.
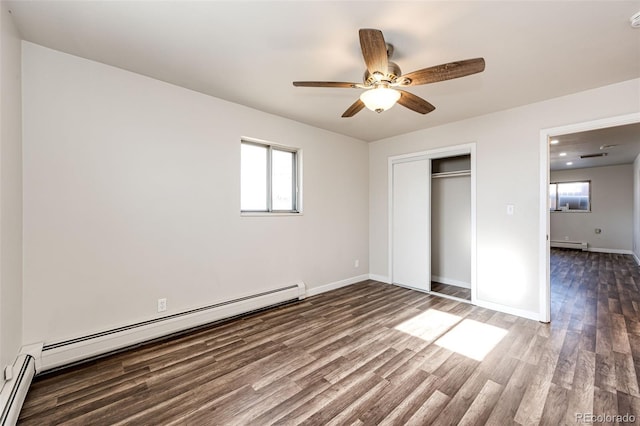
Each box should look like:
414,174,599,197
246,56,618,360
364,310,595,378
550,164,633,252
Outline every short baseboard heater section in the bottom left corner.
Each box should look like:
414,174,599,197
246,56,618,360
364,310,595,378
0,354,36,426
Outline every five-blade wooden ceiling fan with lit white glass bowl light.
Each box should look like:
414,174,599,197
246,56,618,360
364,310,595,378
293,28,484,117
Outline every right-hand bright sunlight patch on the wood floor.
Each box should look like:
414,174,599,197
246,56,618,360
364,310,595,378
435,319,507,361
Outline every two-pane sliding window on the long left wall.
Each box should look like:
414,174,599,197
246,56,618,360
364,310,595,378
240,140,299,213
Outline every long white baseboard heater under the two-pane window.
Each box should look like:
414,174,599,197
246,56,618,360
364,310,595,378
36,282,306,373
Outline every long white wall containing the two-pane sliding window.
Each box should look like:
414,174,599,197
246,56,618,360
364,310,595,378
23,42,369,343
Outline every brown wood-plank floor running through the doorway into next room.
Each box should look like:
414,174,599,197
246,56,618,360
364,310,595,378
19,250,640,426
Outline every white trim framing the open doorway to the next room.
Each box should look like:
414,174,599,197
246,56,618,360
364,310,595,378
538,113,640,322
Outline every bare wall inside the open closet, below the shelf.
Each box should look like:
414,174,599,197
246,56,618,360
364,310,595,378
431,176,471,288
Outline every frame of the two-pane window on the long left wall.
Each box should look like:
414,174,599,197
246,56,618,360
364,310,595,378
240,137,302,216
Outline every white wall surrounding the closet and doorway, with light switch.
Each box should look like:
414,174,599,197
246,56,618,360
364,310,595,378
369,79,640,318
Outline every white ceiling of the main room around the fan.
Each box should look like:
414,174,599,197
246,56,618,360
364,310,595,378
3,0,640,141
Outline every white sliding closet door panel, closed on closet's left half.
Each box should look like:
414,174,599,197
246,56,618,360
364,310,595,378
392,159,431,290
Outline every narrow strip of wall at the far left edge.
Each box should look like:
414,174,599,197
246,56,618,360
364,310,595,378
0,2,22,368
